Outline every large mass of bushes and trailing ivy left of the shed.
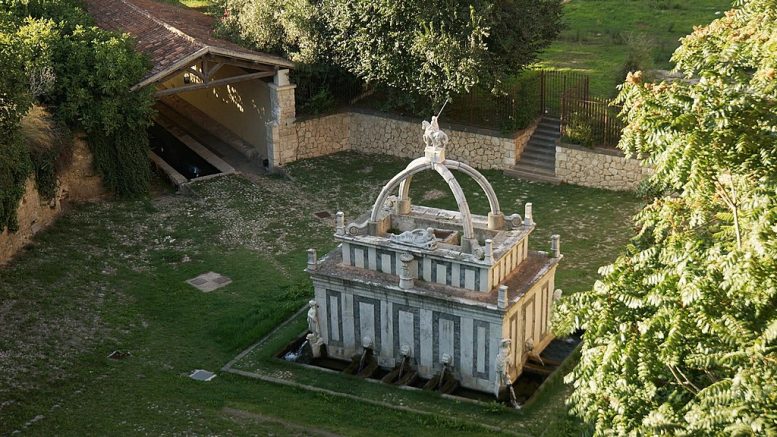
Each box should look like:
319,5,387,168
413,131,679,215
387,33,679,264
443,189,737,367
0,0,153,230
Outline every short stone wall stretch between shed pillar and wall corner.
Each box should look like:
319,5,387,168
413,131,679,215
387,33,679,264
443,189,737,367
294,112,351,161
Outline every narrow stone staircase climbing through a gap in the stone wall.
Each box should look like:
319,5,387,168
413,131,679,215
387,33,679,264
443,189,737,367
505,116,561,184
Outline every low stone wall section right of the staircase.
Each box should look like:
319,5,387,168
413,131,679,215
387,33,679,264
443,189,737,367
556,144,652,191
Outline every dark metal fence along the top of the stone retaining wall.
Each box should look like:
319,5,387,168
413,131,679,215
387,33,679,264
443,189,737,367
297,70,623,143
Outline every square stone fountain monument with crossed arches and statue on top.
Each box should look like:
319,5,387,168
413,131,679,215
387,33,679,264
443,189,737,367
307,117,562,396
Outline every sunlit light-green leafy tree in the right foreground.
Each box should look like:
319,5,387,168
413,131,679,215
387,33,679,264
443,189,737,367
557,0,777,435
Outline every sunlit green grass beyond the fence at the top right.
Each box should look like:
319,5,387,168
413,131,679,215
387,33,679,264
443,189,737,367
540,0,731,97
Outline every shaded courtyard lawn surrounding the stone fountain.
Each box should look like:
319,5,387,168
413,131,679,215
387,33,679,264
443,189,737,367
0,153,640,435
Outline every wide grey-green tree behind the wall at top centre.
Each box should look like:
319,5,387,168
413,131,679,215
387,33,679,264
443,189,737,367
215,0,561,101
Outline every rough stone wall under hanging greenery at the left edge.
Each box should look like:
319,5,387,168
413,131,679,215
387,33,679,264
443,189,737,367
0,138,105,265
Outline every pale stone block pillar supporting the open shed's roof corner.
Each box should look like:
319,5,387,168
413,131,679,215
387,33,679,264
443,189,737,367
267,70,297,171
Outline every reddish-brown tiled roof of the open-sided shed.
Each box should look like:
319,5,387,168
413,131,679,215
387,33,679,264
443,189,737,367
86,0,294,86
